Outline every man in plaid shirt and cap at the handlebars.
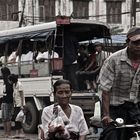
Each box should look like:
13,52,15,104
98,27,140,140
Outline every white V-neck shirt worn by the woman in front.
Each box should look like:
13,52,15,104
42,104,89,138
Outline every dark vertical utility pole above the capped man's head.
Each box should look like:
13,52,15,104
130,0,136,27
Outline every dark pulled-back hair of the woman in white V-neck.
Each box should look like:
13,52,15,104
53,79,72,93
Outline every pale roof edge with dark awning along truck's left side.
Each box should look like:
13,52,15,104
0,22,56,43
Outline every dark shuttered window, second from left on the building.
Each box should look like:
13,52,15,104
39,0,55,22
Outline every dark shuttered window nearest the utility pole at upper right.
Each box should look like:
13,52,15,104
106,1,122,23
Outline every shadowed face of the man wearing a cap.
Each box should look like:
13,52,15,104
128,40,140,57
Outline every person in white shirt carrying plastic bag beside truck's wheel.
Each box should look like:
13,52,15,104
8,74,25,138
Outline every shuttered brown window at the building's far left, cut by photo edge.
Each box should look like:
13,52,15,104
0,0,18,21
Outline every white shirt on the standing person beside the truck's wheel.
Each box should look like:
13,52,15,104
13,81,25,107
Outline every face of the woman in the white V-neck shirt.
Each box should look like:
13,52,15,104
55,84,72,106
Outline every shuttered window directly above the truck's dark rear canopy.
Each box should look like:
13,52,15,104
73,0,89,19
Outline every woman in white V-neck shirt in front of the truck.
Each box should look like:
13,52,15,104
42,80,88,140
